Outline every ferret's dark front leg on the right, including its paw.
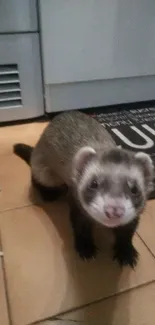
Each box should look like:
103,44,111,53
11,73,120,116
114,218,139,268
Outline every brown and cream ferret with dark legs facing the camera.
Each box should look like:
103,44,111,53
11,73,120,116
14,111,154,267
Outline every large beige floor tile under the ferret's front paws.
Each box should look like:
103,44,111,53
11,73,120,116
0,202,155,325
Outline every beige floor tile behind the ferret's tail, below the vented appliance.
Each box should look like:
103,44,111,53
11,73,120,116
0,122,47,156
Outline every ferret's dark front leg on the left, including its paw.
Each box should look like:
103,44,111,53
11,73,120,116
70,200,97,260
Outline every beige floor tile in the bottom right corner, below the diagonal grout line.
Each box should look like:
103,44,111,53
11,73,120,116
59,283,155,325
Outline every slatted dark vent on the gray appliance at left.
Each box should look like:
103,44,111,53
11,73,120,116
0,64,23,109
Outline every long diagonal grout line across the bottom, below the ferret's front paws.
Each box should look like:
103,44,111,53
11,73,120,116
26,279,155,325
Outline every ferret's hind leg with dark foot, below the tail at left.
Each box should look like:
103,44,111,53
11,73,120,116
32,166,68,201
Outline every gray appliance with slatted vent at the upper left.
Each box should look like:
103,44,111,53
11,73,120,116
0,0,44,122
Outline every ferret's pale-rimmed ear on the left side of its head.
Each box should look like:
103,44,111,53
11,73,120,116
73,147,96,180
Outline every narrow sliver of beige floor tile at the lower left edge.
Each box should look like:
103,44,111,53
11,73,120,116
0,258,9,325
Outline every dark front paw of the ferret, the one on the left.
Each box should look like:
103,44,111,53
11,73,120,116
76,241,98,261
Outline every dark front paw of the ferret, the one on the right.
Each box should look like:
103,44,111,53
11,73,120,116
113,245,139,269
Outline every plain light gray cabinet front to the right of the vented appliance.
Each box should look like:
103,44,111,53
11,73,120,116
40,0,155,112
